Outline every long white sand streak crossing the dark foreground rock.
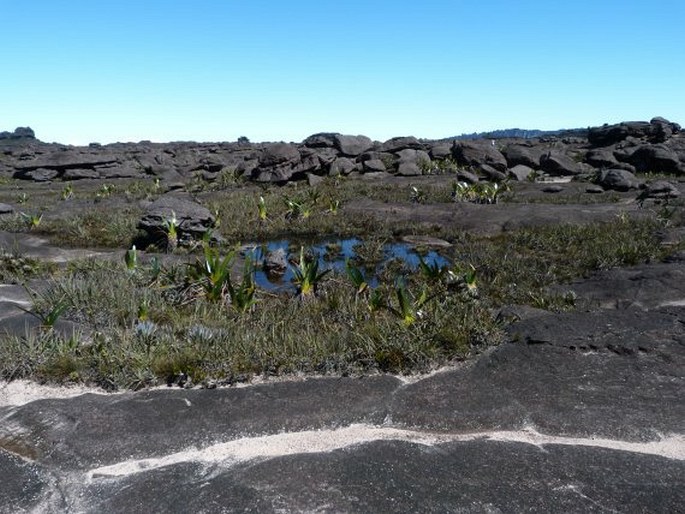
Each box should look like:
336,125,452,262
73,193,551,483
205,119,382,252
88,424,685,479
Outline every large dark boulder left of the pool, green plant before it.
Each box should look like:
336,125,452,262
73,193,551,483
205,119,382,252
138,195,216,243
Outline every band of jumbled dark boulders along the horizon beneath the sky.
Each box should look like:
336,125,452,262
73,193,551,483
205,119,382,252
0,117,685,189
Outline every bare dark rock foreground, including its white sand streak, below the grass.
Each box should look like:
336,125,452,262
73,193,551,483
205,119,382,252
0,256,685,513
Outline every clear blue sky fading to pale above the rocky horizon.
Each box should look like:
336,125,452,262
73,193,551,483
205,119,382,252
0,0,685,144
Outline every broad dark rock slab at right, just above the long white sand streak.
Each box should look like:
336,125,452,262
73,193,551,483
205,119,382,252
392,308,685,441
